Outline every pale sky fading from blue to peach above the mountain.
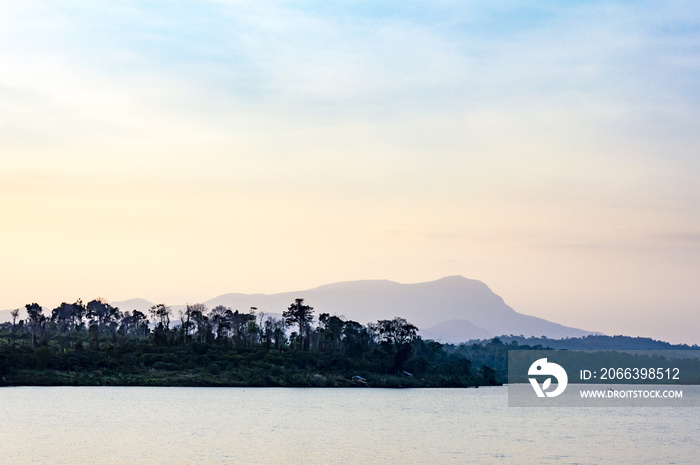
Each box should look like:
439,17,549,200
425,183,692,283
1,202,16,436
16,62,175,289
0,0,700,343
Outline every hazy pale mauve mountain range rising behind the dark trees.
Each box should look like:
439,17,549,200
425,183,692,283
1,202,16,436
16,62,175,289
0,276,596,343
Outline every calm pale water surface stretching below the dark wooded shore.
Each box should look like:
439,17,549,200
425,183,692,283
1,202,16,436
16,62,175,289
0,387,700,465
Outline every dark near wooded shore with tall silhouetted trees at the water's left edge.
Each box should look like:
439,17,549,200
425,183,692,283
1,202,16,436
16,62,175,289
0,299,501,387
